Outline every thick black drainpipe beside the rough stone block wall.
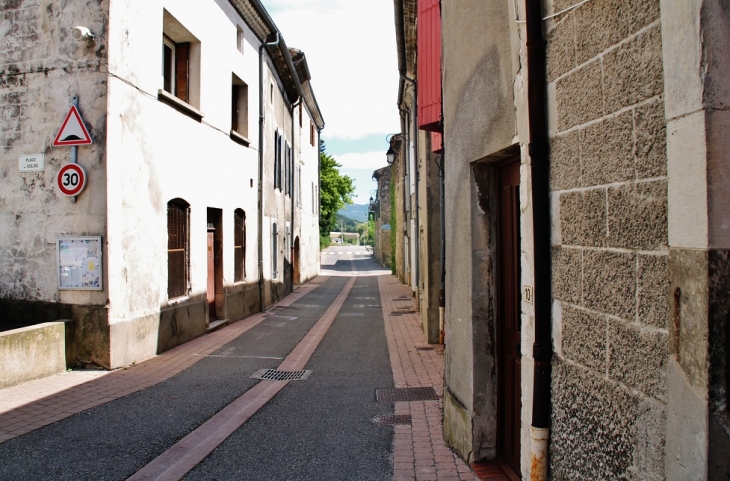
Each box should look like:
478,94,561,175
525,0,553,481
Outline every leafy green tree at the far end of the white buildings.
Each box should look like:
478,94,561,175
319,141,355,247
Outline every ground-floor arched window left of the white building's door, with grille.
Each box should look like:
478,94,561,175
167,199,190,299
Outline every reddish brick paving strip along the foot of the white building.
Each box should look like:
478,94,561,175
0,276,328,443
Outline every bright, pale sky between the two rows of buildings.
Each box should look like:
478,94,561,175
262,0,400,204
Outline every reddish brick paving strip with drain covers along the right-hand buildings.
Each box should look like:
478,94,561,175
378,276,484,481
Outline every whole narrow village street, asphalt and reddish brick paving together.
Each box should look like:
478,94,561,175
0,246,490,480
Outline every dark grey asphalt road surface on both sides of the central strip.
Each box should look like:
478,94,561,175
0,246,393,480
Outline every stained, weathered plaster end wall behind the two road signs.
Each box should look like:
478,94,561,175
0,1,109,363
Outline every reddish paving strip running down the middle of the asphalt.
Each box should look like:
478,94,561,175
129,277,356,481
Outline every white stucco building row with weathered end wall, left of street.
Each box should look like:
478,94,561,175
0,0,324,368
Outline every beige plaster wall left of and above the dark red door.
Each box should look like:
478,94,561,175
441,0,520,460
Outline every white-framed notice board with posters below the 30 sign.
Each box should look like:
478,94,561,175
56,236,102,291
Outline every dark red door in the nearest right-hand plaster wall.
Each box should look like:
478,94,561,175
497,160,522,473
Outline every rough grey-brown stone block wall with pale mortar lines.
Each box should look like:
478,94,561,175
546,0,669,480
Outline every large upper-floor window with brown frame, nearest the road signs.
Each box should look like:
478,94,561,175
158,10,202,117
